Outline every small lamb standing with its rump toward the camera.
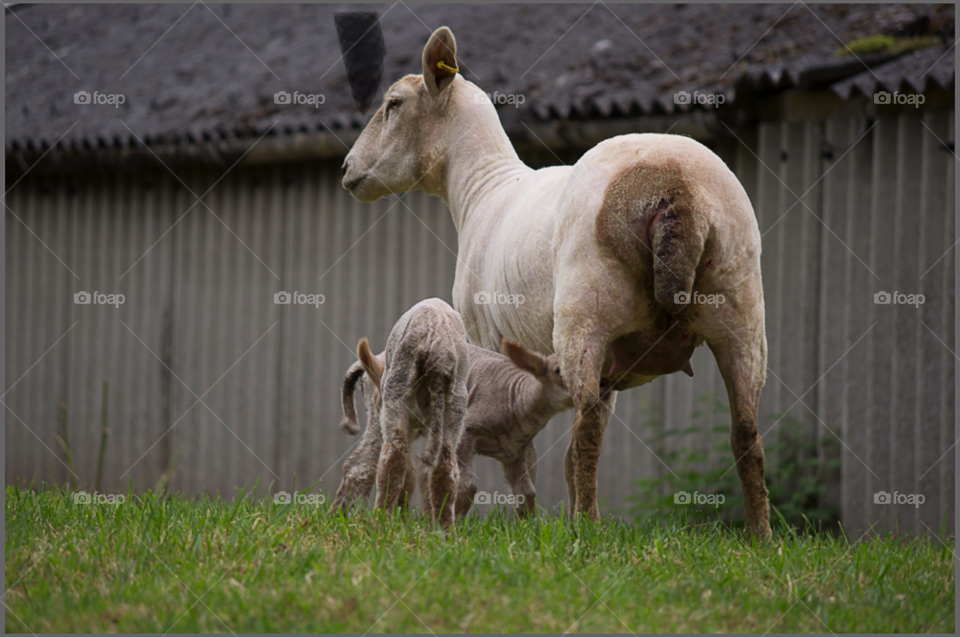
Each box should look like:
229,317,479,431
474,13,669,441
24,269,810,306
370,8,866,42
357,299,468,527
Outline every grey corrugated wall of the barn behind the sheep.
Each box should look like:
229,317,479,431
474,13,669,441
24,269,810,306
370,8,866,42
4,112,955,531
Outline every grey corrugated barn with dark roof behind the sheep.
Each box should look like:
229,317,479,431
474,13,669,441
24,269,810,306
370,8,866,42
2,2,957,533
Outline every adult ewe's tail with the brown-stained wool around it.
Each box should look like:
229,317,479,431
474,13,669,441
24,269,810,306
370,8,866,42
596,164,709,313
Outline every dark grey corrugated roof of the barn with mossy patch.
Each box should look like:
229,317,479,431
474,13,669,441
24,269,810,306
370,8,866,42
6,3,954,152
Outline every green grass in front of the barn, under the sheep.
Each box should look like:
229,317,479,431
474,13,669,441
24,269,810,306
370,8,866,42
4,488,954,633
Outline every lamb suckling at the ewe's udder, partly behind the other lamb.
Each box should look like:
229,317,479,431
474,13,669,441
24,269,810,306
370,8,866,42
334,339,573,518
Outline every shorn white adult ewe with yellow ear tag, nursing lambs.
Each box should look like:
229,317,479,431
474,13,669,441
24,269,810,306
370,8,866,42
343,27,770,536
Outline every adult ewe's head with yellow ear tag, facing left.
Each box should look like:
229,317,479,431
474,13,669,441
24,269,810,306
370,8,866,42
343,27,497,201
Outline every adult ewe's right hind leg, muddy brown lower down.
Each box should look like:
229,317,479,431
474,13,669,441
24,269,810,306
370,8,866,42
707,315,770,537
